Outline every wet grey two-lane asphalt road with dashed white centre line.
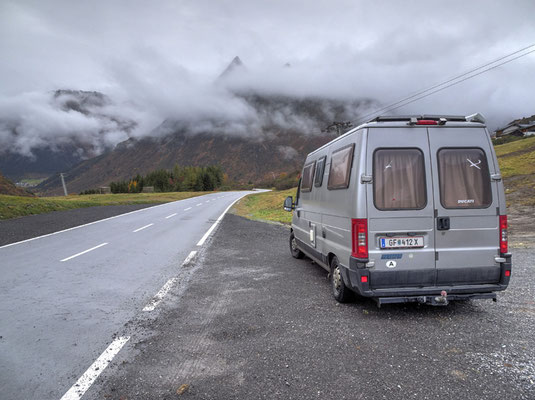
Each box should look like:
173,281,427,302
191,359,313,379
0,192,254,399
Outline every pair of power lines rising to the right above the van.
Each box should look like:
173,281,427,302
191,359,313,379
355,44,535,125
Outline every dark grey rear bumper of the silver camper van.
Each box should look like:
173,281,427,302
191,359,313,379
342,257,511,303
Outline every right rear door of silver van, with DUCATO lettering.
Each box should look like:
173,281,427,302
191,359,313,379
428,127,500,286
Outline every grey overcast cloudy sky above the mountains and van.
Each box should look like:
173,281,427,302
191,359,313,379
0,0,535,156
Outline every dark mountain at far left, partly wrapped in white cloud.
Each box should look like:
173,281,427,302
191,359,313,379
0,90,136,181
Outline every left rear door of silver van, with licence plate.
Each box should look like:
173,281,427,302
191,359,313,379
366,127,436,290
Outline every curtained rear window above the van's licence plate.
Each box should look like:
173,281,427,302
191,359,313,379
373,148,427,210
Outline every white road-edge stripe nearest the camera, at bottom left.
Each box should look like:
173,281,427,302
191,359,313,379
61,336,130,400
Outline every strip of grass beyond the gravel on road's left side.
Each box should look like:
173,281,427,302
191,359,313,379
0,192,211,219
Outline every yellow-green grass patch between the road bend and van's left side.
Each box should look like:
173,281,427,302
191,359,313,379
233,188,297,225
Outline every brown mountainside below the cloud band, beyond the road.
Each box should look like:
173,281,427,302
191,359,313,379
36,123,340,195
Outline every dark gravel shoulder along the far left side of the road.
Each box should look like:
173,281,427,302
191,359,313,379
0,204,156,246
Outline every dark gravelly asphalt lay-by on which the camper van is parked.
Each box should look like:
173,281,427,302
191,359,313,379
84,214,535,400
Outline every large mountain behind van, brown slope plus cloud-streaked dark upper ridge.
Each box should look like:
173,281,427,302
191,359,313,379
36,93,370,195
